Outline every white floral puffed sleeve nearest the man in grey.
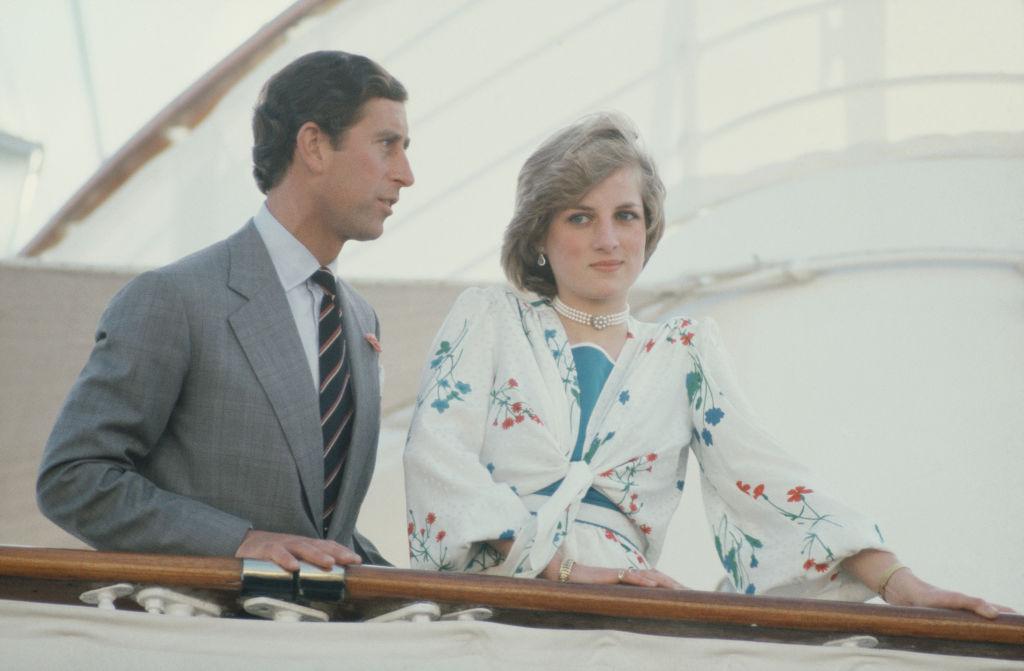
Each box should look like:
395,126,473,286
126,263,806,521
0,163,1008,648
404,289,529,571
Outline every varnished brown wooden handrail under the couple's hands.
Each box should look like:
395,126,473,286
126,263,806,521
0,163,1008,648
0,547,1024,659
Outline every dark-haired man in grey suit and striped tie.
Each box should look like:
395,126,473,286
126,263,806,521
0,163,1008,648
37,51,413,571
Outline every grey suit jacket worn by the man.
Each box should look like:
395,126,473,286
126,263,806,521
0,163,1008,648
37,221,383,562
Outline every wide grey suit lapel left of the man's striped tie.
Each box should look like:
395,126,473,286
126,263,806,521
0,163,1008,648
227,222,323,529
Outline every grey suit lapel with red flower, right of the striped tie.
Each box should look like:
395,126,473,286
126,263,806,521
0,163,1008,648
328,280,381,538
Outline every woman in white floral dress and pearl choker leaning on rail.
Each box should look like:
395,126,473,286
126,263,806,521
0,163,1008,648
406,115,996,617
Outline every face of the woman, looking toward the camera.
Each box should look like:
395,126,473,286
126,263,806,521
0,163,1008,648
543,167,646,313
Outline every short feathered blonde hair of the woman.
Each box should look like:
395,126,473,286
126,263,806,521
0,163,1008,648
502,113,665,297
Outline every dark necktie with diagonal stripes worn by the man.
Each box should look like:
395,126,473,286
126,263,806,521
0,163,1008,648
310,267,355,536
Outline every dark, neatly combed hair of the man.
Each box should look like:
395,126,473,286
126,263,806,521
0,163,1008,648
253,51,408,194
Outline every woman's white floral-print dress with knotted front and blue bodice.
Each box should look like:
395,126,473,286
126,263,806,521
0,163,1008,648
406,288,882,599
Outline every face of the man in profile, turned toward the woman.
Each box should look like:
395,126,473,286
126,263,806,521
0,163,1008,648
316,98,413,244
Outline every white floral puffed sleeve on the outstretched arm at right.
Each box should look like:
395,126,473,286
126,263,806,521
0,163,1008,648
686,320,883,599
